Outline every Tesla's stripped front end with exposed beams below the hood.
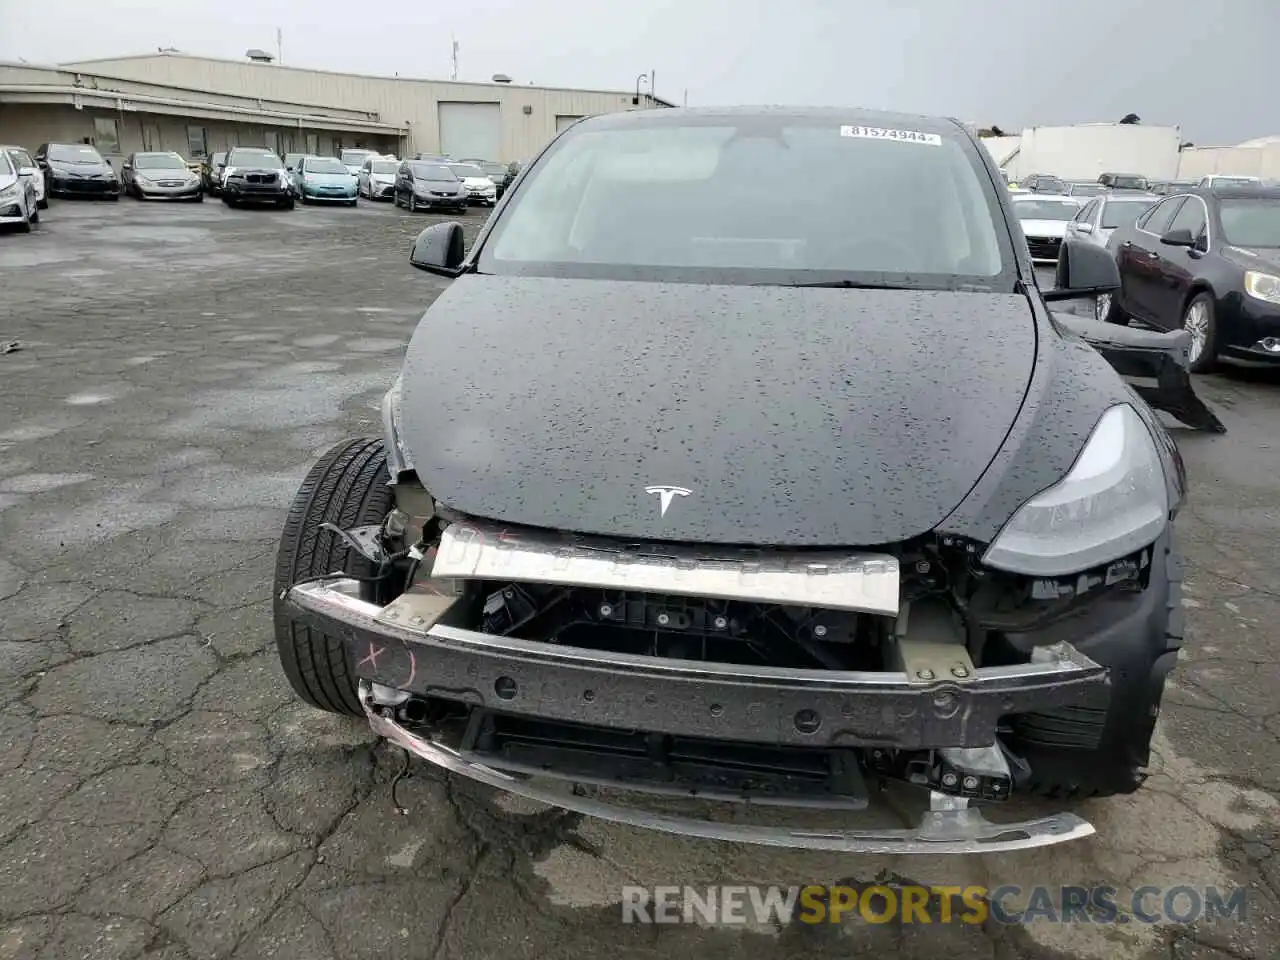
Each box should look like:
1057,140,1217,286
285,504,1167,854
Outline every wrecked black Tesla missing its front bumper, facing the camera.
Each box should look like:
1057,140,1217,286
274,108,1208,854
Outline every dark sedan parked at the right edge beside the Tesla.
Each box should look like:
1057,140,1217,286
1098,184,1280,372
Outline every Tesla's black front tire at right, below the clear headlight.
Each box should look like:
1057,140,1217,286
1010,534,1184,800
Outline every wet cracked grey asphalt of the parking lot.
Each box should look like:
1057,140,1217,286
0,201,1280,960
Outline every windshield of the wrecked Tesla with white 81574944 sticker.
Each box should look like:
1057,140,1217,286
480,116,1012,289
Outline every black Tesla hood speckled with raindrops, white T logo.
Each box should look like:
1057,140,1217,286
398,274,1037,545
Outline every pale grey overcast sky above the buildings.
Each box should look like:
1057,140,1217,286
0,0,1280,145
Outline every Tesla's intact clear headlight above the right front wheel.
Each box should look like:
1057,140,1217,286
982,403,1169,576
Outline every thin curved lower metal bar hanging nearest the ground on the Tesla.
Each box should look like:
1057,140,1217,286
361,681,1094,855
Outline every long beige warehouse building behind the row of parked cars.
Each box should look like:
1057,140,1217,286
0,51,671,171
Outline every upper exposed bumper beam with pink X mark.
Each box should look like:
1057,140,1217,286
287,577,1106,749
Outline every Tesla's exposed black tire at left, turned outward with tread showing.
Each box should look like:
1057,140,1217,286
274,439,396,717
